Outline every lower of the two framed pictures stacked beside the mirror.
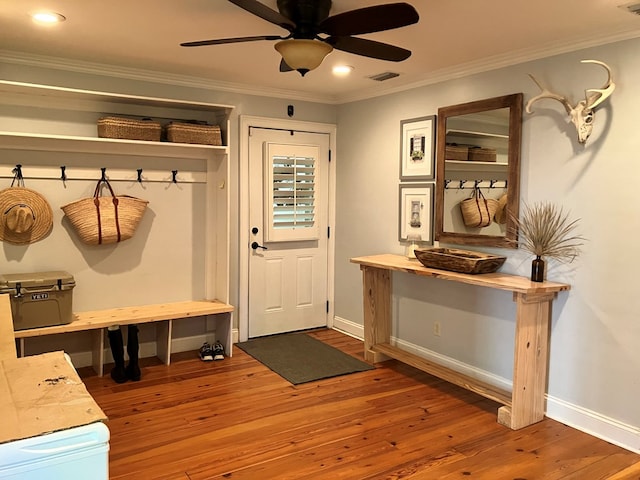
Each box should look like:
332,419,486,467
398,183,433,245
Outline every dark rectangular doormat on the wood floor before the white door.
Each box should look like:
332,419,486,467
237,333,375,385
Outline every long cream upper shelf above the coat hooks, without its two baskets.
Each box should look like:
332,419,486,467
0,80,233,150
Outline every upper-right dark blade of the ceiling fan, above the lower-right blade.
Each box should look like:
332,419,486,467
319,2,420,37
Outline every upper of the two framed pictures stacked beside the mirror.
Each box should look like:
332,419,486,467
400,115,437,180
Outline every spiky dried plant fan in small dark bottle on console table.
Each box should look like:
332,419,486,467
513,202,585,282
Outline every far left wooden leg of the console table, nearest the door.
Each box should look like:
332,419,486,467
361,265,391,363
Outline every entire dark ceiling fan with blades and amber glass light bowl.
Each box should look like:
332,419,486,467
180,0,420,76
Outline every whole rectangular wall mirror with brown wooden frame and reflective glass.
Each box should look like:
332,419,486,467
435,93,522,248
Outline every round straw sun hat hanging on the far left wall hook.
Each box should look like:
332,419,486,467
0,187,53,245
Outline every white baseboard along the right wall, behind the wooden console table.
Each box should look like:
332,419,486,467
333,317,640,453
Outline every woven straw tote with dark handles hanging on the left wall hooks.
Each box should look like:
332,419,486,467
62,179,149,245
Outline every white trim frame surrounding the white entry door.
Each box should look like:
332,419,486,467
237,115,337,342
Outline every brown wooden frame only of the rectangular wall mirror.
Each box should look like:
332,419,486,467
435,93,522,248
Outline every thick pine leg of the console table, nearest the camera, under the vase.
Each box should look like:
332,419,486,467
498,293,556,430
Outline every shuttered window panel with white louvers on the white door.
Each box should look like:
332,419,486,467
264,143,319,242
